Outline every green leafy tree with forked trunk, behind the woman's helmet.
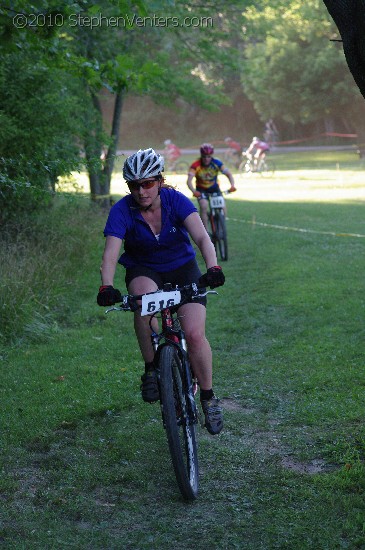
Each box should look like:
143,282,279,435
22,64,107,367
61,1,239,204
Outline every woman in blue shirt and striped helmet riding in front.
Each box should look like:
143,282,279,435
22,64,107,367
97,148,225,435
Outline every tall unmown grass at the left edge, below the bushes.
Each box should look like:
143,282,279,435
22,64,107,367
0,195,105,353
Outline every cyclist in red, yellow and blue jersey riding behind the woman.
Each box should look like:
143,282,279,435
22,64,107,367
186,143,236,230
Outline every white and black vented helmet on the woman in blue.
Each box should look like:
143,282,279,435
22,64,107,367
123,148,165,181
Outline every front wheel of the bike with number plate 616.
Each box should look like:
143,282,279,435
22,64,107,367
159,345,199,500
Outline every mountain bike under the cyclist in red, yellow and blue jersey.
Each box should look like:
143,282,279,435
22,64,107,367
206,191,228,261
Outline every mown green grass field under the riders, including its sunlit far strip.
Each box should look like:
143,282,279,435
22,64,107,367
0,149,365,550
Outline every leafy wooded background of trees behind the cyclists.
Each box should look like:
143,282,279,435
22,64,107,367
0,0,365,222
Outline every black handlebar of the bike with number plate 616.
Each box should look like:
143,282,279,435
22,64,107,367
105,283,218,313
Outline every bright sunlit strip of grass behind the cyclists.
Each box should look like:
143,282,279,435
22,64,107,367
62,151,365,202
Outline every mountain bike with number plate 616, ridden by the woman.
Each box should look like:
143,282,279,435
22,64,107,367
106,283,217,500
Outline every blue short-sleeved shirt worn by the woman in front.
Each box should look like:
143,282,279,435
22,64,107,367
104,187,197,273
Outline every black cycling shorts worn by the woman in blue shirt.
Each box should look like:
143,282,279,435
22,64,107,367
125,259,207,306
